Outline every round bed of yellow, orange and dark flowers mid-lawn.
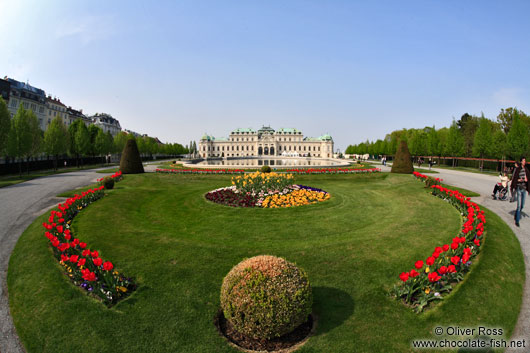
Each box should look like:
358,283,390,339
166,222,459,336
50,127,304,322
205,172,330,208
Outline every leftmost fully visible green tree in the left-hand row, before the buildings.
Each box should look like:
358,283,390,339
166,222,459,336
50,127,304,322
7,104,33,177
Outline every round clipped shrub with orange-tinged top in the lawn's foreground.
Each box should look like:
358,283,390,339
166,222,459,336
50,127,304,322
221,255,313,340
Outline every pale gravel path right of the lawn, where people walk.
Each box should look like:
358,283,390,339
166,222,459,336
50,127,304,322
377,165,530,353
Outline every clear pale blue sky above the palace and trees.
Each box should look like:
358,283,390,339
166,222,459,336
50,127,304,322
0,0,530,150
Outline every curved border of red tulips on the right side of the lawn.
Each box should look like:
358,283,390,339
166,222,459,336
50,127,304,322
392,172,486,312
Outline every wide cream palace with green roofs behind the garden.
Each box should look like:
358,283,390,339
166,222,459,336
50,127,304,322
199,126,333,158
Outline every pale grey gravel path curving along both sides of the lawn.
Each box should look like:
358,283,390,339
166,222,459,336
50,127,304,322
0,162,530,353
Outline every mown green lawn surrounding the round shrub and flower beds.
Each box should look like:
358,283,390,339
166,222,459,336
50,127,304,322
8,173,524,352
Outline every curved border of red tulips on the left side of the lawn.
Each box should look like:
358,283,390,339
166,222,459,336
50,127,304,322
42,173,137,307
